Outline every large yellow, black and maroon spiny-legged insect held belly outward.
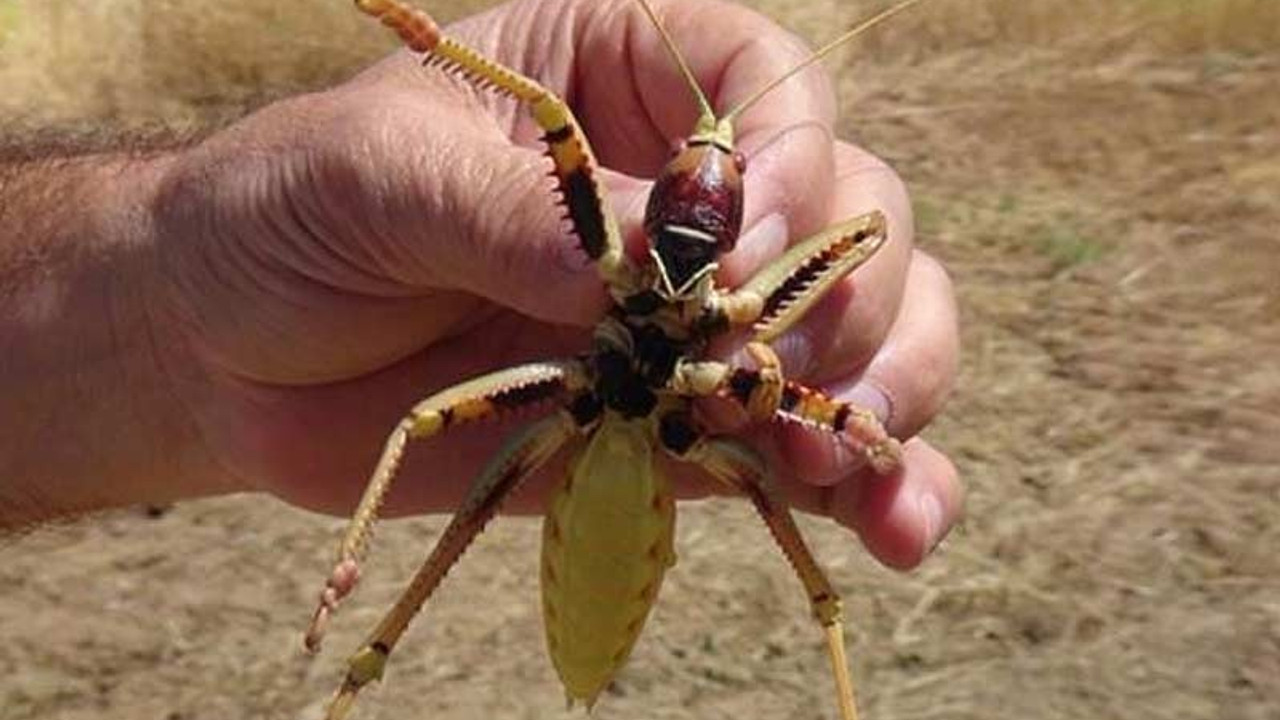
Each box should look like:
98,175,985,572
306,0,919,720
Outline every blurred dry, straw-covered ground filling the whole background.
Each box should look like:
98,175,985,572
0,0,1280,720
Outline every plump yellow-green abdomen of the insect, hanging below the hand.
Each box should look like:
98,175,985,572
541,414,676,706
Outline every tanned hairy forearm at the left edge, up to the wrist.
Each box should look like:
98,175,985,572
0,146,225,529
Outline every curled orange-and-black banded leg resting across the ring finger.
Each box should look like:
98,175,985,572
672,356,902,475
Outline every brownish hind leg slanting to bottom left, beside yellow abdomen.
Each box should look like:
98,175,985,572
325,411,579,720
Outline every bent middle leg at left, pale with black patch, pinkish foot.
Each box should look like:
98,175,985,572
305,361,588,651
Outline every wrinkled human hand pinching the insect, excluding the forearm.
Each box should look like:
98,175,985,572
145,0,960,568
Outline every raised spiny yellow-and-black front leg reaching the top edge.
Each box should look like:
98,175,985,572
356,0,644,299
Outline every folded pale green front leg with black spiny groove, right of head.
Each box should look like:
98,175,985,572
721,211,888,342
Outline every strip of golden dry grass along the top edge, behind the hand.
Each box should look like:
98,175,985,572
0,0,1280,122
